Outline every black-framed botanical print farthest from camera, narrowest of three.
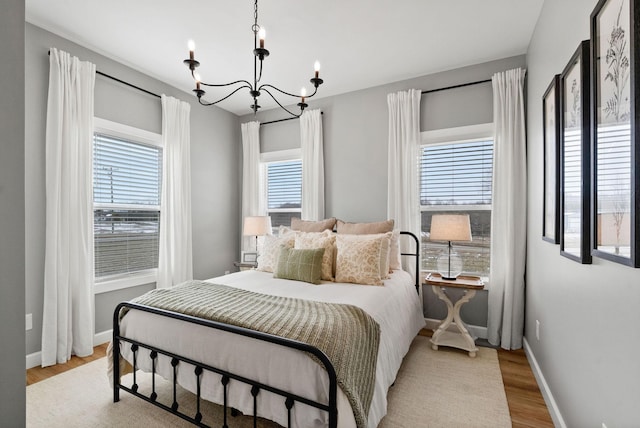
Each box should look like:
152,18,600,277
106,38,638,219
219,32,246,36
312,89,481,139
542,74,560,244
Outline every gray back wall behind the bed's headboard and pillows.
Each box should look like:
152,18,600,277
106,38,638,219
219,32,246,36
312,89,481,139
241,56,525,326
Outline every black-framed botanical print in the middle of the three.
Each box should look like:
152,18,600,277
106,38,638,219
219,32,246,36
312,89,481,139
560,40,591,263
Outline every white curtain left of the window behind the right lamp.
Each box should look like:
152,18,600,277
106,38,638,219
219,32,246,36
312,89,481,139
387,89,422,275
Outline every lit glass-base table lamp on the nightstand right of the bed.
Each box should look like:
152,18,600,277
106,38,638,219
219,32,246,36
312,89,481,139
429,214,471,281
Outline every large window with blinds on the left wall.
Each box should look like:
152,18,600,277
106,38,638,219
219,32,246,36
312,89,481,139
93,119,162,292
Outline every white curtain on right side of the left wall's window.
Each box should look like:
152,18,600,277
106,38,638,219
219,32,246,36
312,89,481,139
156,95,193,288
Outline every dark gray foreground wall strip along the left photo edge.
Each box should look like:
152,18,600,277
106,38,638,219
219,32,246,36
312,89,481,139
0,0,25,427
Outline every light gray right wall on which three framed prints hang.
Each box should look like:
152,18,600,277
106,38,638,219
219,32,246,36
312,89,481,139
525,0,640,427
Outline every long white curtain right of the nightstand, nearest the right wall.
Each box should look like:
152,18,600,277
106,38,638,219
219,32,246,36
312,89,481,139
487,69,527,349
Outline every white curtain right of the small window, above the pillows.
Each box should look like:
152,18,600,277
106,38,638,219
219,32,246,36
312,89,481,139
300,110,324,220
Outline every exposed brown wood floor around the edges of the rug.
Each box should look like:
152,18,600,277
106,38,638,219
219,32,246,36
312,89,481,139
27,336,553,428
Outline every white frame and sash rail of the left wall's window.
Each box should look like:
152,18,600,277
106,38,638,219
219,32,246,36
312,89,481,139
91,117,164,294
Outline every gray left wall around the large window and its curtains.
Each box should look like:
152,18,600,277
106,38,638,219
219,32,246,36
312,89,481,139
24,24,241,354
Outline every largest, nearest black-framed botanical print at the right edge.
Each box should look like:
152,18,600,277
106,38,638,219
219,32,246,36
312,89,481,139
591,0,640,267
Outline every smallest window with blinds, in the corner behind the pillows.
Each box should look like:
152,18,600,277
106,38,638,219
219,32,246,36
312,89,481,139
262,150,302,228
